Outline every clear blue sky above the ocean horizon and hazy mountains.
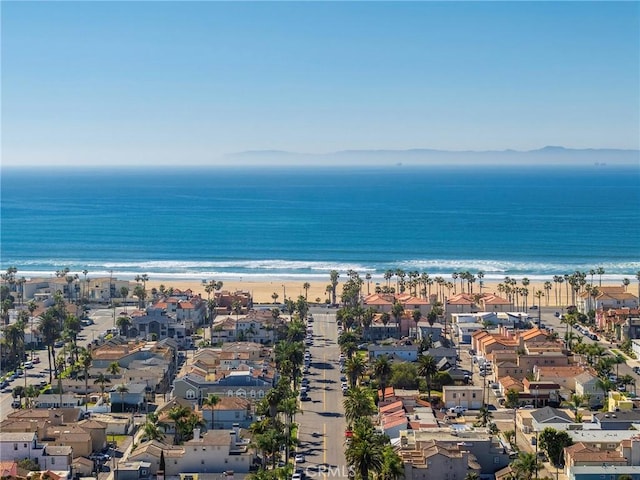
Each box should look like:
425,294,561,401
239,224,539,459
1,1,640,166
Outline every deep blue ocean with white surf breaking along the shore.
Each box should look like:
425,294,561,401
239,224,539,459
0,165,640,281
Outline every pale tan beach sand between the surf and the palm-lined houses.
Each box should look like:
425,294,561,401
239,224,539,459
139,275,621,307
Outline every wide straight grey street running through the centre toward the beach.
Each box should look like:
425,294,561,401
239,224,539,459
296,309,347,478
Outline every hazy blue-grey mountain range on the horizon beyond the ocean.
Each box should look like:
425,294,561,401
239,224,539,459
224,146,640,166
